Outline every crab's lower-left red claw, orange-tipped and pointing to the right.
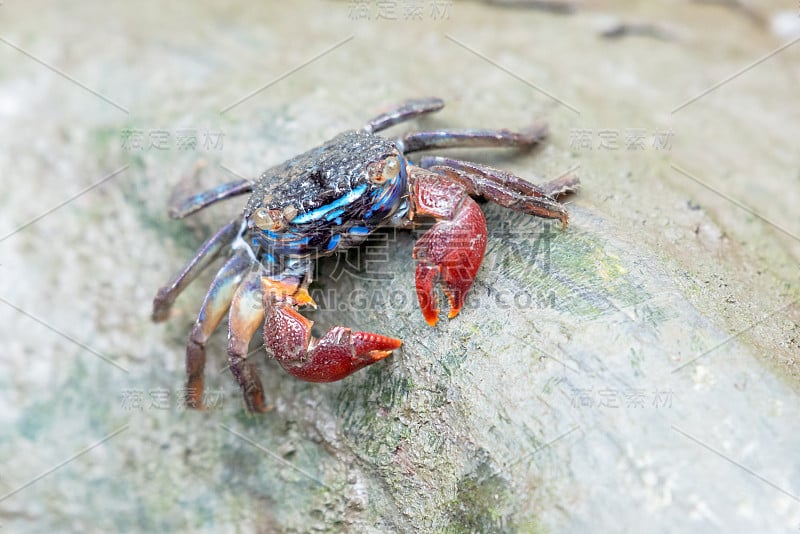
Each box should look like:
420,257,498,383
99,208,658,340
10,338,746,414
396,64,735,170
261,277,402,382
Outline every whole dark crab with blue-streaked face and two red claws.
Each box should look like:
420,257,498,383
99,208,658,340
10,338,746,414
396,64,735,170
153,98,579,412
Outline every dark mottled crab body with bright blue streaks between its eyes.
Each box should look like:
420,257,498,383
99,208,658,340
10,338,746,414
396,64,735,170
244,131,408,262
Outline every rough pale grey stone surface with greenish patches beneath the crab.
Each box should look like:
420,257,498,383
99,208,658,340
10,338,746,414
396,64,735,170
0,2,800,532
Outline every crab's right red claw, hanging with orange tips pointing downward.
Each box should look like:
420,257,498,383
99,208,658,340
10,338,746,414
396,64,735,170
410,167,487,326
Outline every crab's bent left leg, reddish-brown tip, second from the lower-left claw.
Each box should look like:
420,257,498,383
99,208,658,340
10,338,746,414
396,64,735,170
186,250,252,409
